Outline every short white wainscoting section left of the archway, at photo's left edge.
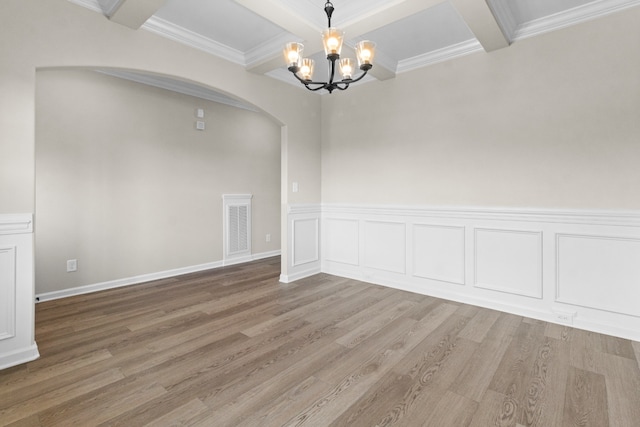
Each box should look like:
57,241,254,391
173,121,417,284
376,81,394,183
0,214,39,369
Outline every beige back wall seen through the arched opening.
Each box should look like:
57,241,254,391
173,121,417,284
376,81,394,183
36,69,280,294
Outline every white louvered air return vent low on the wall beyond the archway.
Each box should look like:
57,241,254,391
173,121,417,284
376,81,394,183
222,194,252,265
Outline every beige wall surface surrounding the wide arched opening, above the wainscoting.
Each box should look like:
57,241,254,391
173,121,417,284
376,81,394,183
0,0,320,280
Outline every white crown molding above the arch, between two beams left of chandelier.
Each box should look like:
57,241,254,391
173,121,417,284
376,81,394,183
142,16,245,66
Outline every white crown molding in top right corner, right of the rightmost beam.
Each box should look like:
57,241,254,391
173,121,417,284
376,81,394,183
511,0,640,41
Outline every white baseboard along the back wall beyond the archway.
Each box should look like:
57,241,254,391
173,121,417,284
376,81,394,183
36,250,281,303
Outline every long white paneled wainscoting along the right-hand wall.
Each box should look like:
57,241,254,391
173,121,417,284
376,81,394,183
322,205,640,341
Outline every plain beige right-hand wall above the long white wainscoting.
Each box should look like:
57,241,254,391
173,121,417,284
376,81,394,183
322,7,640,209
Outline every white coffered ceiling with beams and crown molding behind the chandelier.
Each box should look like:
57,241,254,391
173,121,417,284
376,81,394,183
69,0,640,104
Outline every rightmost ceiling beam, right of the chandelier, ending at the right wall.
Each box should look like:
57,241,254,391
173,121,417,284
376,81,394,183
453,0,509,52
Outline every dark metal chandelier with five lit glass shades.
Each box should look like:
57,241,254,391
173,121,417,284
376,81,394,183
284,1,376,93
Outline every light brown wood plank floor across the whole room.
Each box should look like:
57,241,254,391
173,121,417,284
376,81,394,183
0,258,640,427
